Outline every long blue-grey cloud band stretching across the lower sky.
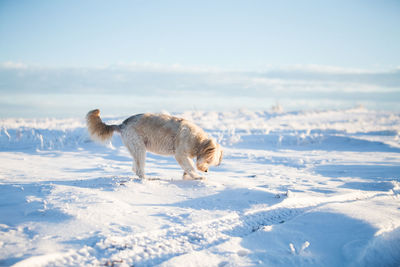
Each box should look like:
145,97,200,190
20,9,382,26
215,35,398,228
0,62,400,96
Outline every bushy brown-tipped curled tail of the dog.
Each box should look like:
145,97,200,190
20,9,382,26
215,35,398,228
86,109,121,142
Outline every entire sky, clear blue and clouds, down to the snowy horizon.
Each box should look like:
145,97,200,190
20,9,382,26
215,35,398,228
0,0,400,117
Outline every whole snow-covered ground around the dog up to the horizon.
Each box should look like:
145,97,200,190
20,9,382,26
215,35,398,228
0,108,400,266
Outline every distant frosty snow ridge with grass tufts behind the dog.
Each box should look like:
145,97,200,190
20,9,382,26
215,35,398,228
0,108,400,151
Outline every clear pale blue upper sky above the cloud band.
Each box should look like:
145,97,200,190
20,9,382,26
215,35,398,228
0,0,400,70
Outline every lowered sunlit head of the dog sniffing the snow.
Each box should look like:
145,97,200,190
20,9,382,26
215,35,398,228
196,139,223,172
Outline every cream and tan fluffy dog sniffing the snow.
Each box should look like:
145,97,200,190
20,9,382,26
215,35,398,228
86,109,223,180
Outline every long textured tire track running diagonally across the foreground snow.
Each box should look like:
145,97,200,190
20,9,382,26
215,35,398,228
33,192,387,266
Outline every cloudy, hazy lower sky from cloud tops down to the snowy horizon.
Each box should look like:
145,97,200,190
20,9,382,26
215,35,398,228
0,62,400,118
